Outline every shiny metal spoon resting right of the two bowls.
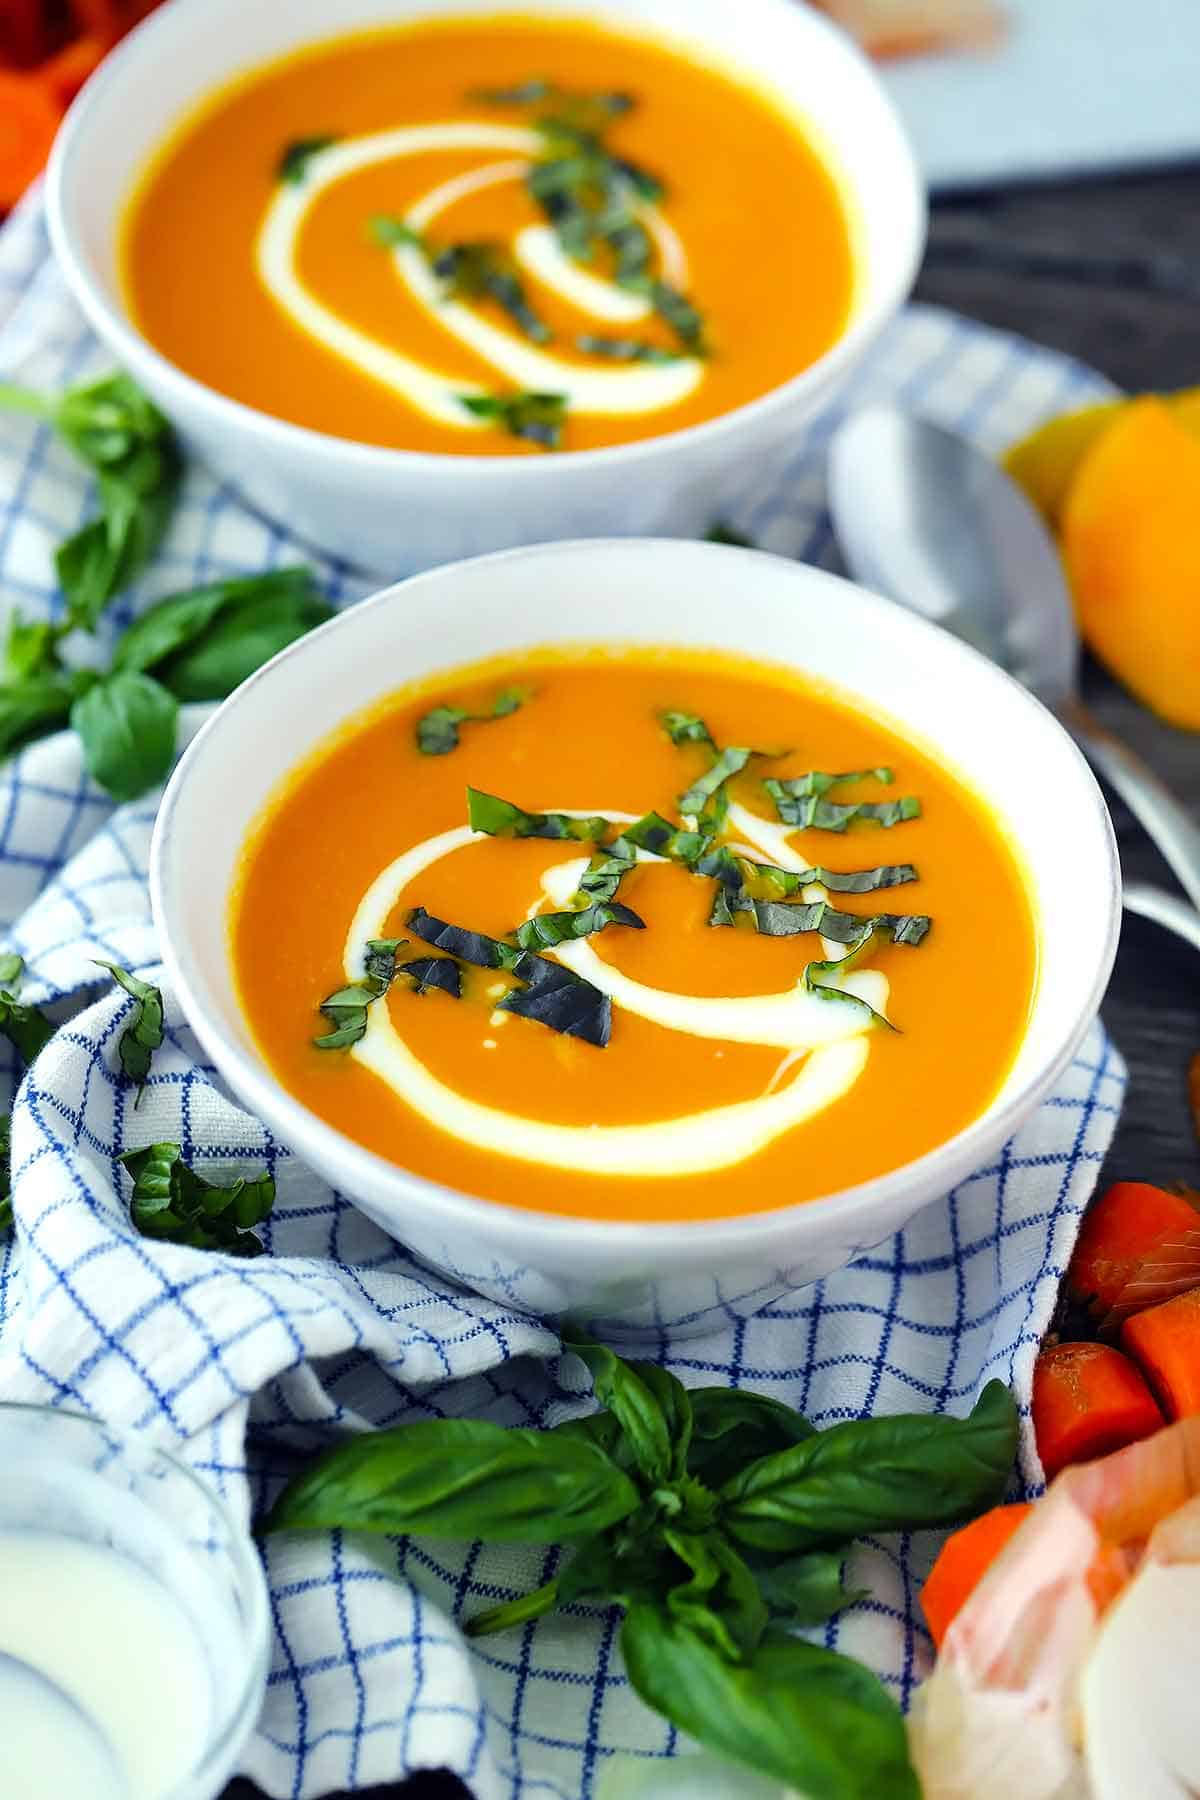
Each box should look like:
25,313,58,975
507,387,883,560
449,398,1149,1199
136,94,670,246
829,407,1200,947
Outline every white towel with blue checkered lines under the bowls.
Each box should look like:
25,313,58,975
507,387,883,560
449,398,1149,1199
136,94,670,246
0,189,1124,1800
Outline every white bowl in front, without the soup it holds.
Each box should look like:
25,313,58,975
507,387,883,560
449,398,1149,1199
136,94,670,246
151,538,1121,1336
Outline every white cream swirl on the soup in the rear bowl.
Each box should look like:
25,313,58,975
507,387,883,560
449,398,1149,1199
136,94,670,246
255,121,703,430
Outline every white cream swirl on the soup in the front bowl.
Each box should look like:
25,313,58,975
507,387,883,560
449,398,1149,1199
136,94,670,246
344,808,887,1179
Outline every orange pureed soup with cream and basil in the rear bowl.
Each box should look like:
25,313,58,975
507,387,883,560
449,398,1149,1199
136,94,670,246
122,18,853,455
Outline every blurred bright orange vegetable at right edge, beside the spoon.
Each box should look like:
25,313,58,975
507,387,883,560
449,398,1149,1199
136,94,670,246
1061,398,1200,731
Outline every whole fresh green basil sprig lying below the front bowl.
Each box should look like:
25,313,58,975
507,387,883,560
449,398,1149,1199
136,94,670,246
266,1336,1016,1800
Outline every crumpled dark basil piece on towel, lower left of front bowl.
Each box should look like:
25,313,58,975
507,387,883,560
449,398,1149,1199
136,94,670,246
117,1143,275,1256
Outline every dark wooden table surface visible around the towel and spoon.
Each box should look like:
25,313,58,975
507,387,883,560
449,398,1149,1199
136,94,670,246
225,169,1200,1800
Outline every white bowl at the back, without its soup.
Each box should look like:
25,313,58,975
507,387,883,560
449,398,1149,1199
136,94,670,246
47,0,925,578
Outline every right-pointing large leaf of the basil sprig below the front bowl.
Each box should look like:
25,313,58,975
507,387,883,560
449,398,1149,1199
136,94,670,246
720,1381,1016,1553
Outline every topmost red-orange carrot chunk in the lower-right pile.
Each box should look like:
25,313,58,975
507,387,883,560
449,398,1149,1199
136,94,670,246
1067,1181,1200,1318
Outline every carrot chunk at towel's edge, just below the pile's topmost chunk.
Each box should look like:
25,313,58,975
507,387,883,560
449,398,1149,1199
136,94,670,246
1033,1345,1162,1481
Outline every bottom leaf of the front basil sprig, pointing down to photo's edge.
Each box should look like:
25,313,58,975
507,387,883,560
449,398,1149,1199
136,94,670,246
621,1602,921,1800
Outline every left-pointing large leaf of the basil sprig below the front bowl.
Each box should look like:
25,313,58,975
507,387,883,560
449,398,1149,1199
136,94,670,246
266,1418,639,1544
